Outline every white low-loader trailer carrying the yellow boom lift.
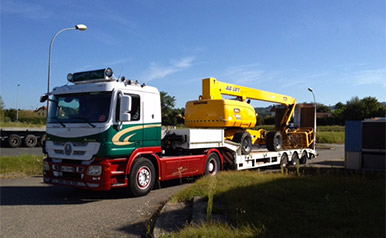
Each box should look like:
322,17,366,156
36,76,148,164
164,129,317,170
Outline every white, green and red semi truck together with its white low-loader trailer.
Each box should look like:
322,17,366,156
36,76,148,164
40,68,316,196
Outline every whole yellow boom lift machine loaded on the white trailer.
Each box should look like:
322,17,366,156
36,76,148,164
185,78,314,154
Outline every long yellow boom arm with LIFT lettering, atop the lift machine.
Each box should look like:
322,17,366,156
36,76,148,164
202,78,296,127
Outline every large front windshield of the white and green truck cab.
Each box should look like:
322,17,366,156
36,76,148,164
48,92,111,124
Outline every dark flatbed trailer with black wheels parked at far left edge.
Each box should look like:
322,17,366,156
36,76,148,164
0,128,46,148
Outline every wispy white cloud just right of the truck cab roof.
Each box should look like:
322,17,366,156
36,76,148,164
141,57,194,82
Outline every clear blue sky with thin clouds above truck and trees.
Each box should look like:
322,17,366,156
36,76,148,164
0,0,386,109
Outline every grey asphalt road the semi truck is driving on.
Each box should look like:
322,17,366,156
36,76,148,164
0,145,344,237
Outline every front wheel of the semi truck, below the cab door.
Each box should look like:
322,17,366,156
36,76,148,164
129,157,155,197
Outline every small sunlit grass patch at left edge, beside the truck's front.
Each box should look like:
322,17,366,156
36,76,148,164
0,155,43,178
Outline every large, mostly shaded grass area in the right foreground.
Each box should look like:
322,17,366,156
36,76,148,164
169,171,385,238
